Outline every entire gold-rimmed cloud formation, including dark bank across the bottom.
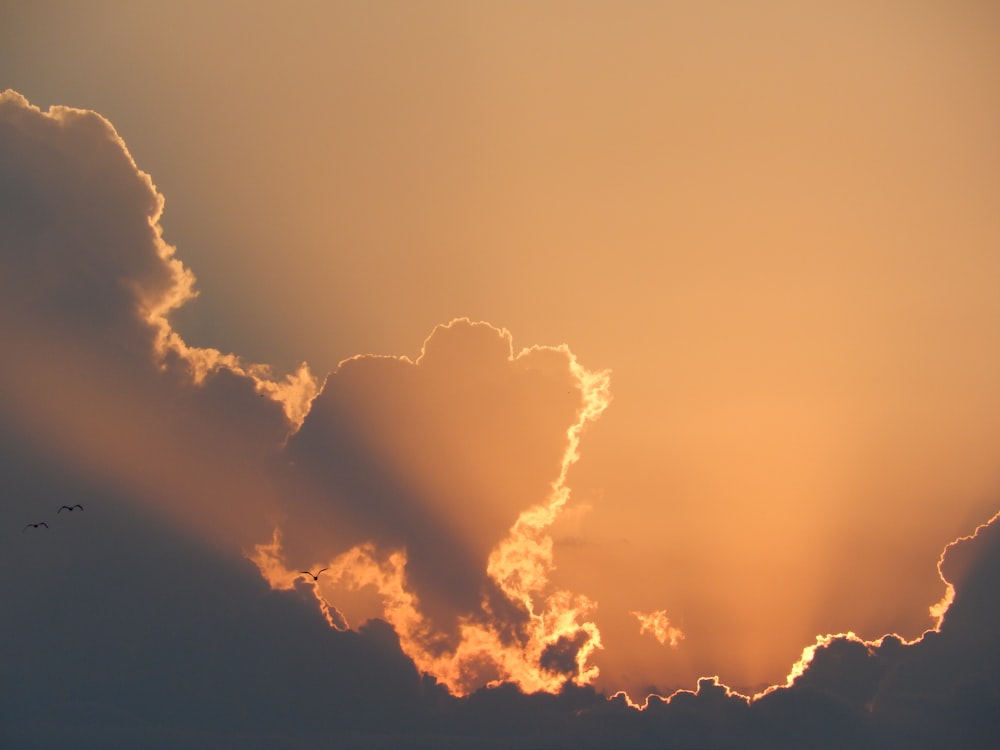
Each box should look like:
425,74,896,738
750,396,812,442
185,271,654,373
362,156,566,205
0,92,1000,748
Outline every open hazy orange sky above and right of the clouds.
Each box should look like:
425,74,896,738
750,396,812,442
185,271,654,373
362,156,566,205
0,2,1000,697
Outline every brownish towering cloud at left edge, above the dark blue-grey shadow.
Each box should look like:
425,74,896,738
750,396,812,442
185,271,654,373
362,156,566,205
0,91,315,546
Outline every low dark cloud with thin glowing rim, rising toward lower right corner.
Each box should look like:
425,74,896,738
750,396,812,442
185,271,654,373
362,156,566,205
564,514,1000,748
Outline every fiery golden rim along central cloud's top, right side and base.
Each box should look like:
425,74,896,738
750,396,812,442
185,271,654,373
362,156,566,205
248,318,611,695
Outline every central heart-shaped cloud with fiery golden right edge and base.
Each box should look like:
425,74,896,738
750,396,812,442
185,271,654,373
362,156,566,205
255,319,608,692
